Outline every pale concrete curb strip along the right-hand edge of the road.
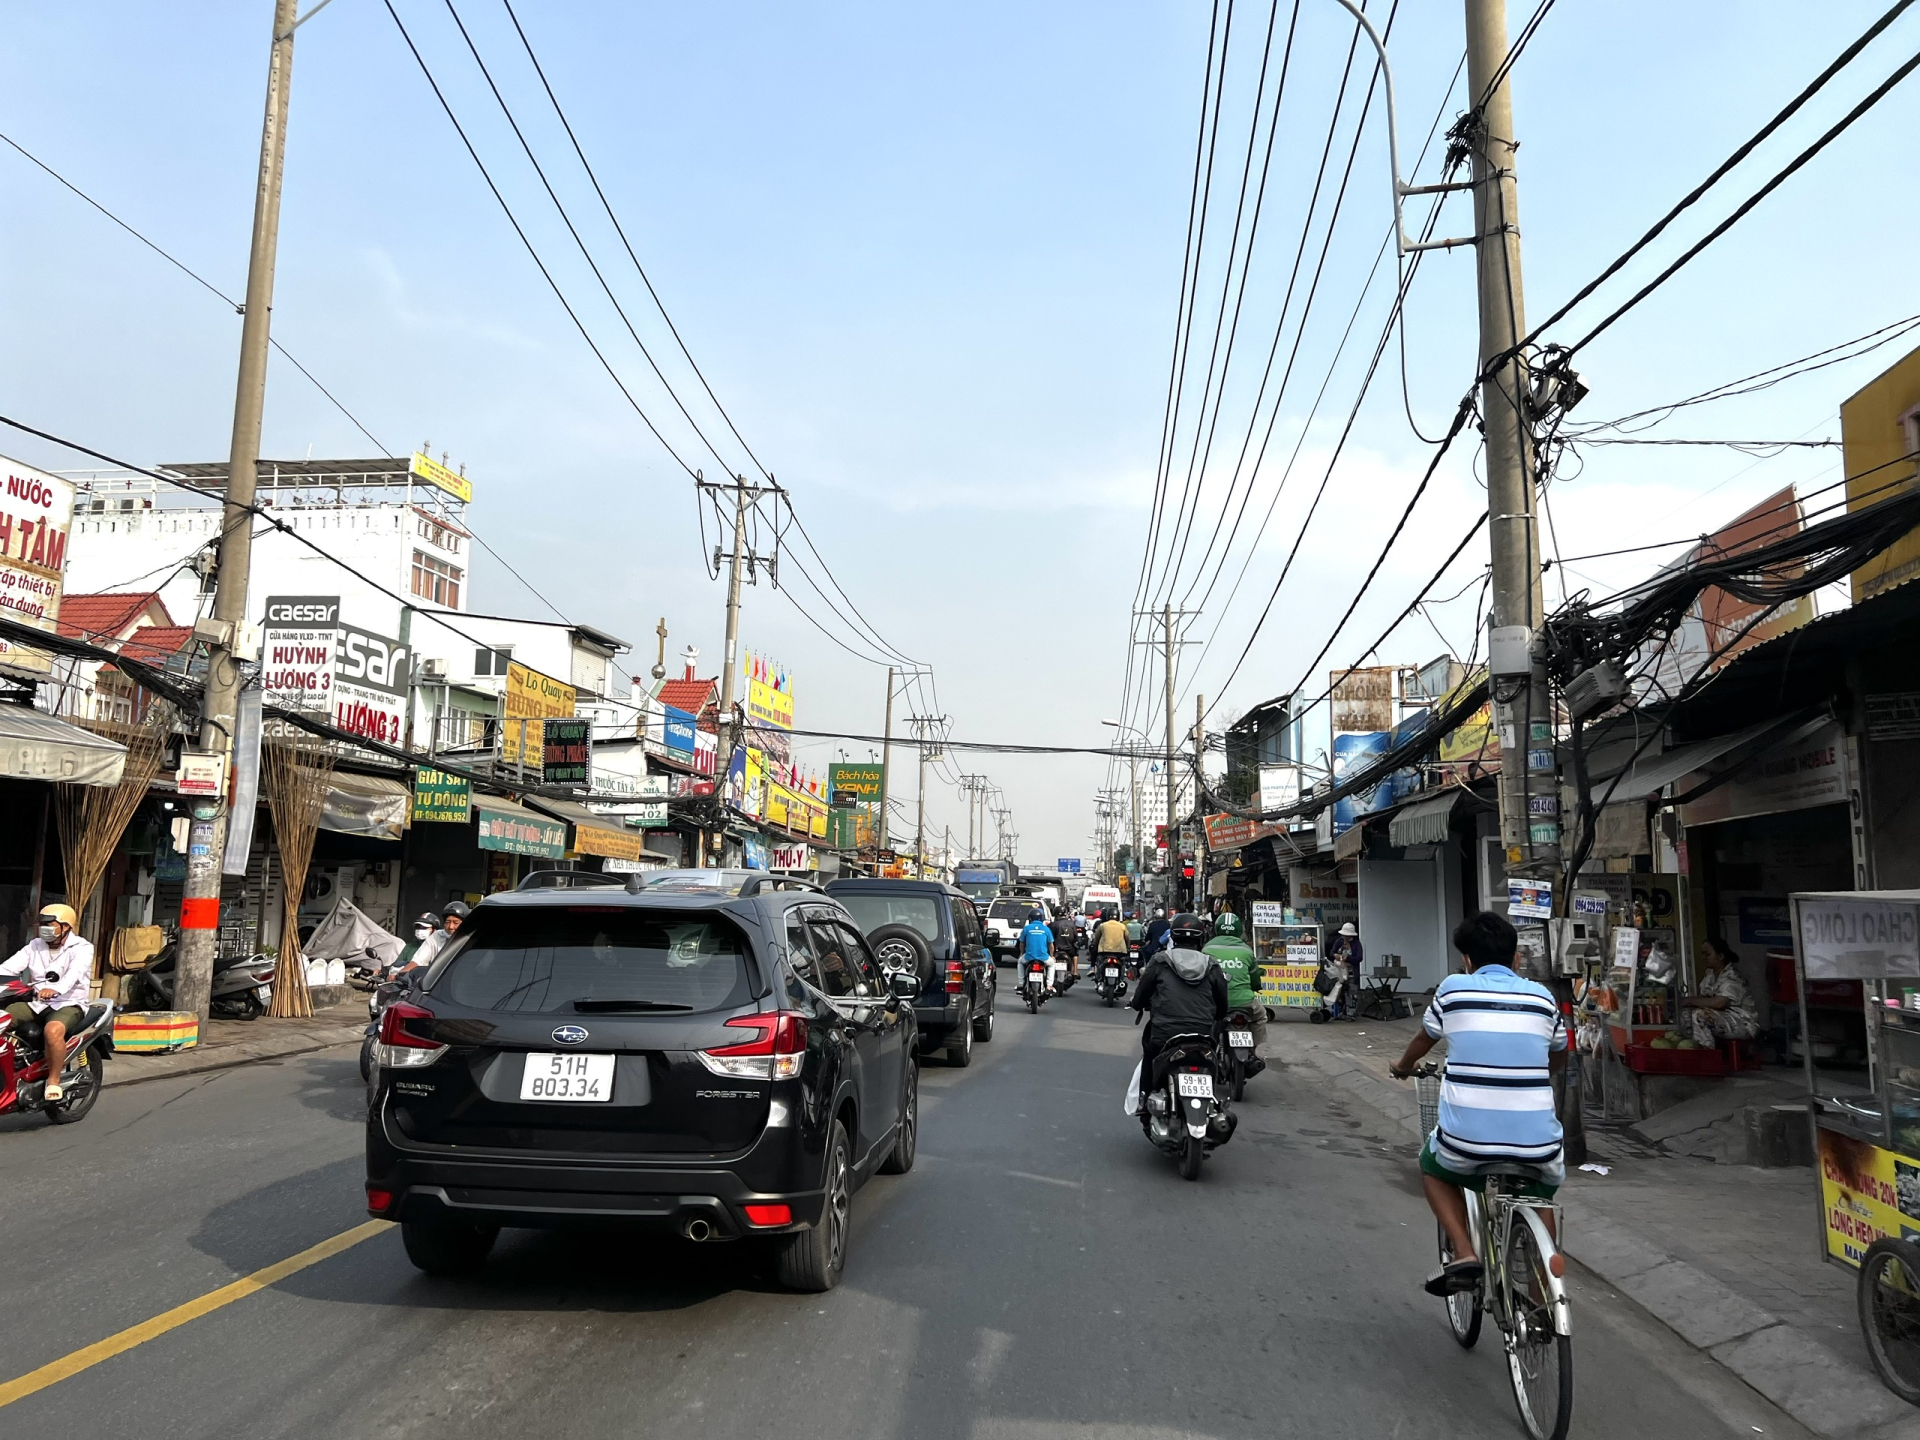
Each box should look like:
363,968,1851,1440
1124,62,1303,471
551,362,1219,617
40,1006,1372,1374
1271,1037,1920,1440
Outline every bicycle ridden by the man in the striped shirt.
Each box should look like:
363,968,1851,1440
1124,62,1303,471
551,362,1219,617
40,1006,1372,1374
1413,1064,1572,1440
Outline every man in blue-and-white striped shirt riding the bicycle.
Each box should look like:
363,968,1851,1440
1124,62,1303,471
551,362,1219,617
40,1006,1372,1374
1392,910,1567,1294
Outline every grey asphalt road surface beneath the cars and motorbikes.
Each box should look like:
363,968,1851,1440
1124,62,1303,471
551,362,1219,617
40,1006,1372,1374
0,985,1805,1440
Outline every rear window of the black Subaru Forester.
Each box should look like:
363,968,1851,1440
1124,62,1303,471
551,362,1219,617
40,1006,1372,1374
432,906,751,1014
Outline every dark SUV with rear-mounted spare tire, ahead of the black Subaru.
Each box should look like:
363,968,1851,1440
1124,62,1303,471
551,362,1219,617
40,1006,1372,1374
828,879,998,1066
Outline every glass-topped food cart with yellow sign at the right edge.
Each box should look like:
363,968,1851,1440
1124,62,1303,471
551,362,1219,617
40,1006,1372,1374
1791,891,1920,1404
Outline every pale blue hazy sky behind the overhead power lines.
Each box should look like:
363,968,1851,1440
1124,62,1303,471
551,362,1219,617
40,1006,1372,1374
0,0,1920,860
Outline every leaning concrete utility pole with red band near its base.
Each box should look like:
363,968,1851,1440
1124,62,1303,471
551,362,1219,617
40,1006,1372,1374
173,0,296,1021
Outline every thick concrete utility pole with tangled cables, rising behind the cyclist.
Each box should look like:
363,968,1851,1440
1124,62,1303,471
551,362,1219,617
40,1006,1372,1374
1467,0,1559,887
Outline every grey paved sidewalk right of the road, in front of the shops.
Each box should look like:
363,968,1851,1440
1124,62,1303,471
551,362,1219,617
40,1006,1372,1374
1269,1020,1920,1440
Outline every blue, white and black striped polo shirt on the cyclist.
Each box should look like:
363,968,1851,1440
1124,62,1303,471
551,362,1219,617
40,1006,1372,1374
1425,966,1567,1173
